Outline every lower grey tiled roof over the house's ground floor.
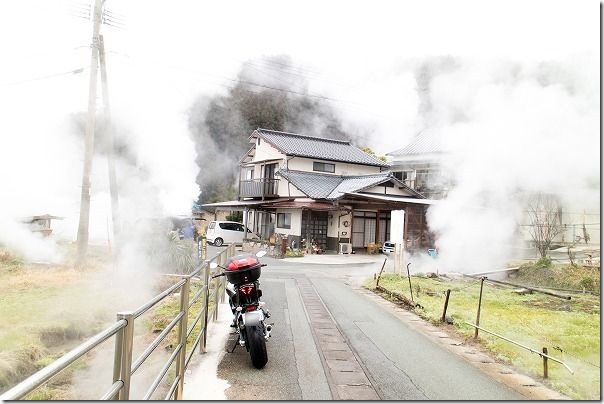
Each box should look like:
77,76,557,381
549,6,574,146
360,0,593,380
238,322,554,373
278,169,423,199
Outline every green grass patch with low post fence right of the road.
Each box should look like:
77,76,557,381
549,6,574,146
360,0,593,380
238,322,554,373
365,274,600,400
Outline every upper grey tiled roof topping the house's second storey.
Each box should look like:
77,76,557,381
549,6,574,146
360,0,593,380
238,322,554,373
250,128,388,167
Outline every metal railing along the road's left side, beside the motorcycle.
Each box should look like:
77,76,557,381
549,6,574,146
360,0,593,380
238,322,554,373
0,245,235,401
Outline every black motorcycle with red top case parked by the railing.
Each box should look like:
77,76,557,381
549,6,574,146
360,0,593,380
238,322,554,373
210,251,272,369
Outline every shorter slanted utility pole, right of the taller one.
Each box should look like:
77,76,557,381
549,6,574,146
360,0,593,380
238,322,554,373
99,35,120,246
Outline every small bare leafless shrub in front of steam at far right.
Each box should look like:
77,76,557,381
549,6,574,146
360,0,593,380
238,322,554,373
527,193,564,258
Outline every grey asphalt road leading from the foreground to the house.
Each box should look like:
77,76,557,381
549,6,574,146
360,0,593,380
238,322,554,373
208,258,528,400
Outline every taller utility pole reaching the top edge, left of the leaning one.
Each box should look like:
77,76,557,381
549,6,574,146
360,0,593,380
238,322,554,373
77,0,102,265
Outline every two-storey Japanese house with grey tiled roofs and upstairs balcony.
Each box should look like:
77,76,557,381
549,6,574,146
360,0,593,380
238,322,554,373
204,129,433,251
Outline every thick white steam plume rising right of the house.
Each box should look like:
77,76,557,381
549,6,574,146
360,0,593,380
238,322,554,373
427,57,599,272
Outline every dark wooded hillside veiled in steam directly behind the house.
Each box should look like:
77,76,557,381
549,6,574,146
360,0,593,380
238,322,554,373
189,56,363,203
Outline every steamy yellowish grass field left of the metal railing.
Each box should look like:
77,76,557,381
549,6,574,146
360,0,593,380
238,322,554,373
0,246,114,400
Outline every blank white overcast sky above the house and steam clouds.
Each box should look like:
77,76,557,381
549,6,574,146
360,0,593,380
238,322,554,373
0,0,600,243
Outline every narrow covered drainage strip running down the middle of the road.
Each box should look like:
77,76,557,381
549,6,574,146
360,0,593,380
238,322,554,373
296,278,380,400
